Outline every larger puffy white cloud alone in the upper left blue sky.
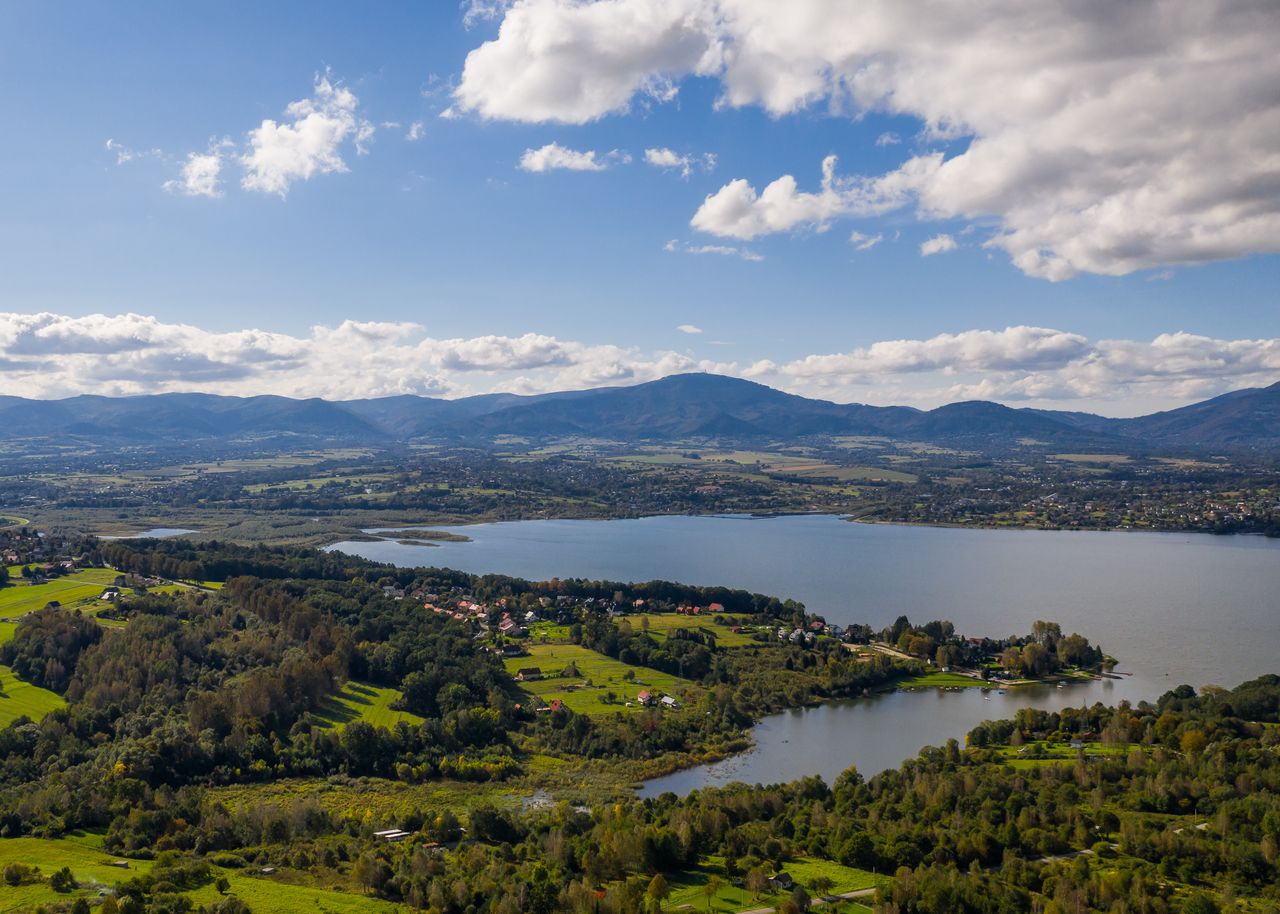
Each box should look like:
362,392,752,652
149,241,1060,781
239,74,374,197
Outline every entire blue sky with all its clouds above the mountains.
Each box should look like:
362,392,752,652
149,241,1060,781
0,0,1280,415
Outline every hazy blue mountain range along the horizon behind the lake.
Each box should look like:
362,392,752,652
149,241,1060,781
0,374,1280,452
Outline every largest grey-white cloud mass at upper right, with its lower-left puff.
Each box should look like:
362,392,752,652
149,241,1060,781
454,0,1280,280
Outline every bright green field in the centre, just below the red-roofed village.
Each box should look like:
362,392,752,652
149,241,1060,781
504,644,694,714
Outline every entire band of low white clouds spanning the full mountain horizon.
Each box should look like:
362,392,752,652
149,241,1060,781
0,312,1280,413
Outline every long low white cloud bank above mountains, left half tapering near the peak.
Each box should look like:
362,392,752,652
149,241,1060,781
0,314,730,399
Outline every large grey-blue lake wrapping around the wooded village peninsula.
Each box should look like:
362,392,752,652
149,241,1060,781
330,515,1280,795
